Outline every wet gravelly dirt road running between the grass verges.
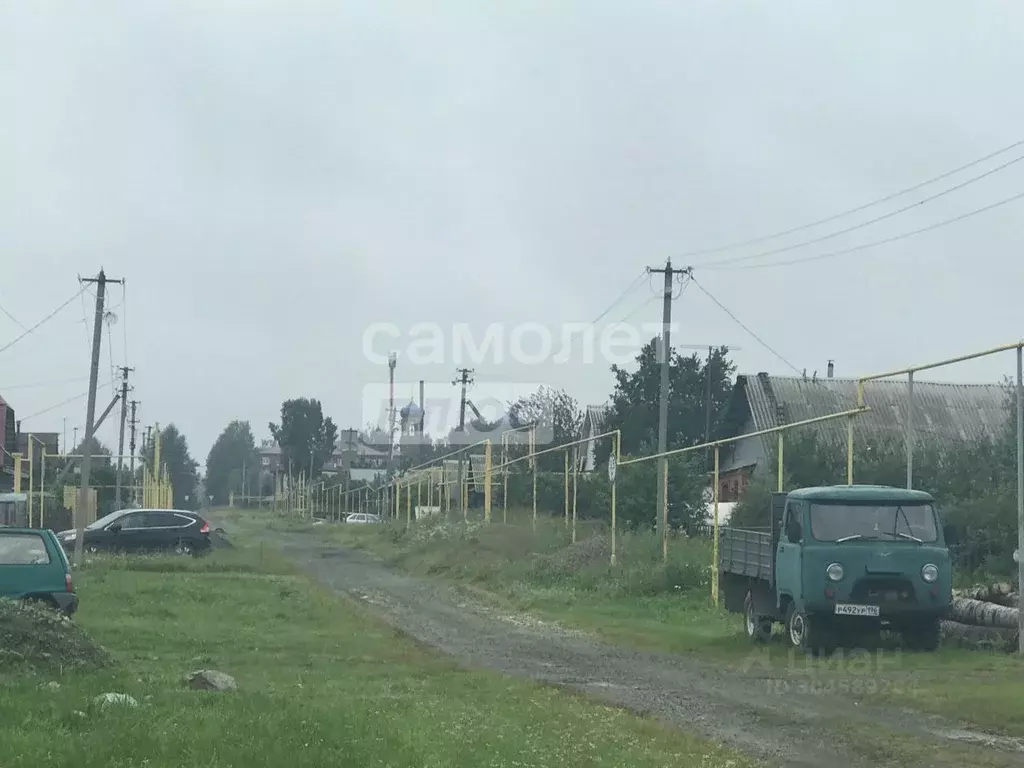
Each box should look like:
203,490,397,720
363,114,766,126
258,532,1024,768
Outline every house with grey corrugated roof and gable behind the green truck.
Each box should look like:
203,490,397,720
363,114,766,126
719,373,1007,502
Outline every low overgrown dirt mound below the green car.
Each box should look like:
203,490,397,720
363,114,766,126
0,598,112,673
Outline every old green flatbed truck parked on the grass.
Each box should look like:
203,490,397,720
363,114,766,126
719,485,952,650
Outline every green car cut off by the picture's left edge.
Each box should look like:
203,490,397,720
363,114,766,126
0,527,78,614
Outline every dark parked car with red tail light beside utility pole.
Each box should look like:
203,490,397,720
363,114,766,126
57,509,210,555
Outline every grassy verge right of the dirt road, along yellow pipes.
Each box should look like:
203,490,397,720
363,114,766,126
301,512,1024,736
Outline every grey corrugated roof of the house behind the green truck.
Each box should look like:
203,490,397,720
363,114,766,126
736,374,1009,444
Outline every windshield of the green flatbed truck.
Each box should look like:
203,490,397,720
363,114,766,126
811,504,938,542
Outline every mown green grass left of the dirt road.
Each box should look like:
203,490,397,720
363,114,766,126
0,536,751,768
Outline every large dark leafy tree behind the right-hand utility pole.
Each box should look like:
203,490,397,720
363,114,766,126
596,339,735,463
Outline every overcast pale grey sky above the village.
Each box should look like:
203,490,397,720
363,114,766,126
0,0,1024,462
